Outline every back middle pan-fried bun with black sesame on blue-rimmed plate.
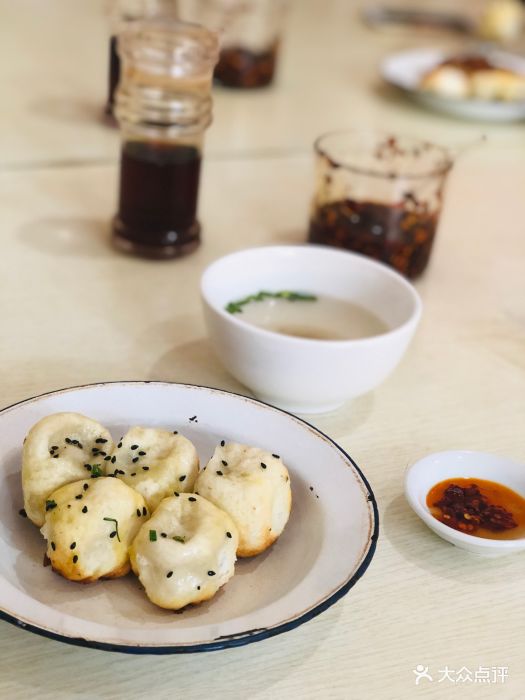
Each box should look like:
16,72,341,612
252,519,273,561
108,427,199,511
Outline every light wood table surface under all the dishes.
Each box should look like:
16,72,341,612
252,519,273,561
0,0,525,700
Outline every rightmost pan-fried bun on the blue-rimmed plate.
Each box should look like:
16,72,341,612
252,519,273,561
195,442,292,557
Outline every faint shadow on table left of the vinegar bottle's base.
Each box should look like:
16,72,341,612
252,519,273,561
19,217,115,258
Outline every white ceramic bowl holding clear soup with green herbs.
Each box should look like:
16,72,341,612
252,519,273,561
201,245,421,413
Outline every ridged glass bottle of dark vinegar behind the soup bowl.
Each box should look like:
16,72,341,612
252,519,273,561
113,18,218,258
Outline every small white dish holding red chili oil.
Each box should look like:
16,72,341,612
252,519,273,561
405,450,525,557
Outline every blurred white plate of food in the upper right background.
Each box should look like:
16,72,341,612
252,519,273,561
380,49,525,122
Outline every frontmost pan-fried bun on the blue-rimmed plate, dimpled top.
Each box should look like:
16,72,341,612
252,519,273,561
130,493,238,610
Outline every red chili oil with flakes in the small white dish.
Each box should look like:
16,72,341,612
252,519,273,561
427,478,525,540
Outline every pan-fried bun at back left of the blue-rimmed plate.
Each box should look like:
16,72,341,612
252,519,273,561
22,413,113,527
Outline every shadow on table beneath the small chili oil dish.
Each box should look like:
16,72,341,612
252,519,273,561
381,495,522,588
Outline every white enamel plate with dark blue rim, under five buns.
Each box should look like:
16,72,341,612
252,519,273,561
0,382,379,654
